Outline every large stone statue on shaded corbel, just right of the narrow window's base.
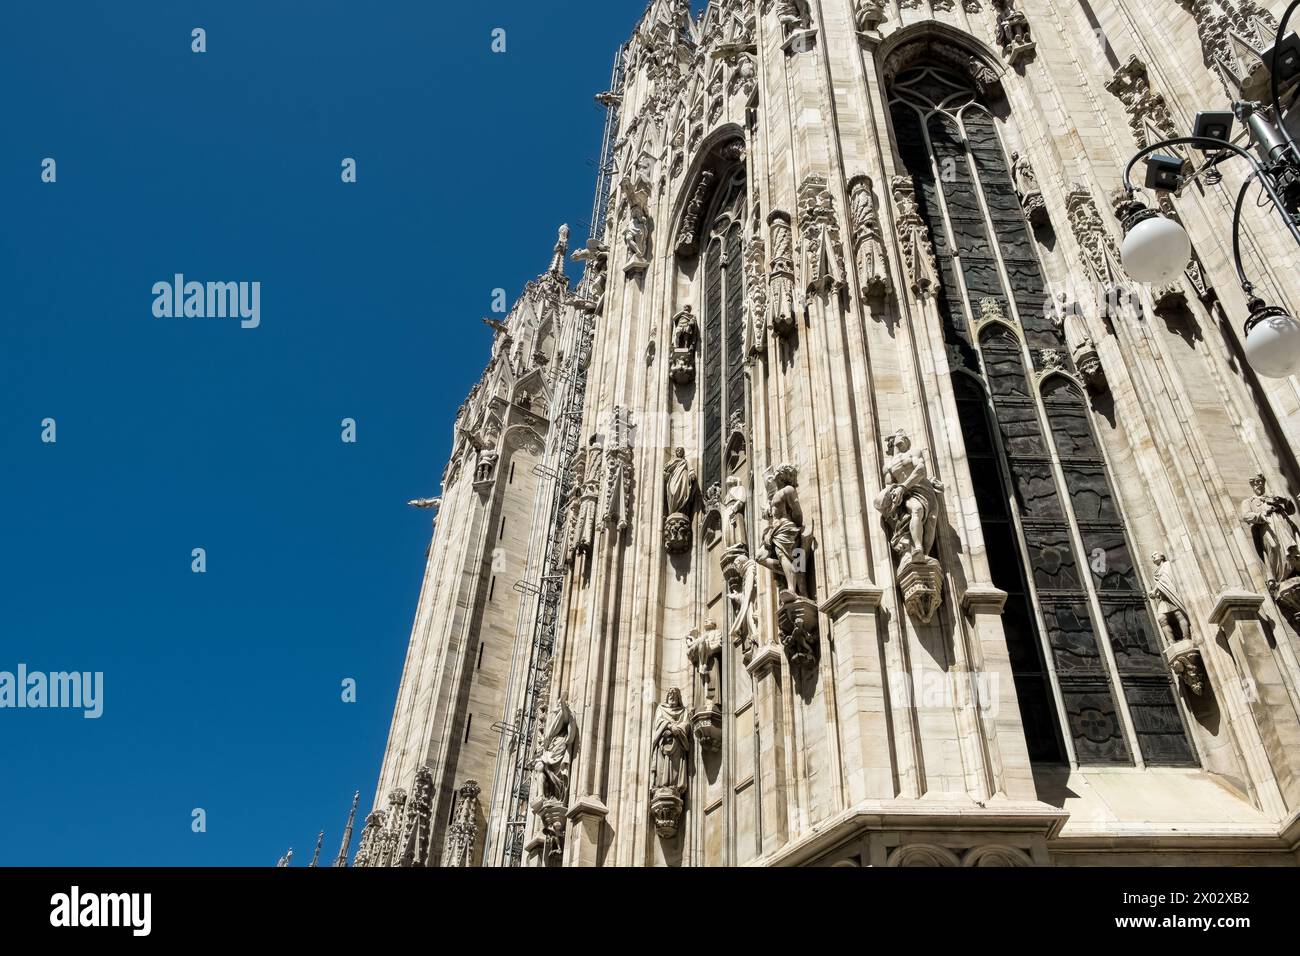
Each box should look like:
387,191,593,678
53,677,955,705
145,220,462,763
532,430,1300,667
755,464,818,666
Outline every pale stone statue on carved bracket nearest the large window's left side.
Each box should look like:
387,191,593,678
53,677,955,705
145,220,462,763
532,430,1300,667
875,429,944,624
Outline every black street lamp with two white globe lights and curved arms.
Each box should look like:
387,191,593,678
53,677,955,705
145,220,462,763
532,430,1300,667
1119,0,1300,378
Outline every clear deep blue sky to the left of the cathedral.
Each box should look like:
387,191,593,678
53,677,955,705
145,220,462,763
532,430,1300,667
0,0,698,865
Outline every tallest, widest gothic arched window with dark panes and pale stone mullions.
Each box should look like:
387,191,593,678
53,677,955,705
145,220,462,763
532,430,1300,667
891,66,1196,766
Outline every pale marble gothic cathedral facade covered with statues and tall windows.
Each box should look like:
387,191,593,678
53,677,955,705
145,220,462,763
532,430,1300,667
356,0,1300,866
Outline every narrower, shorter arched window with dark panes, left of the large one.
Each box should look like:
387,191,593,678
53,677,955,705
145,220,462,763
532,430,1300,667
701,169,748,489
